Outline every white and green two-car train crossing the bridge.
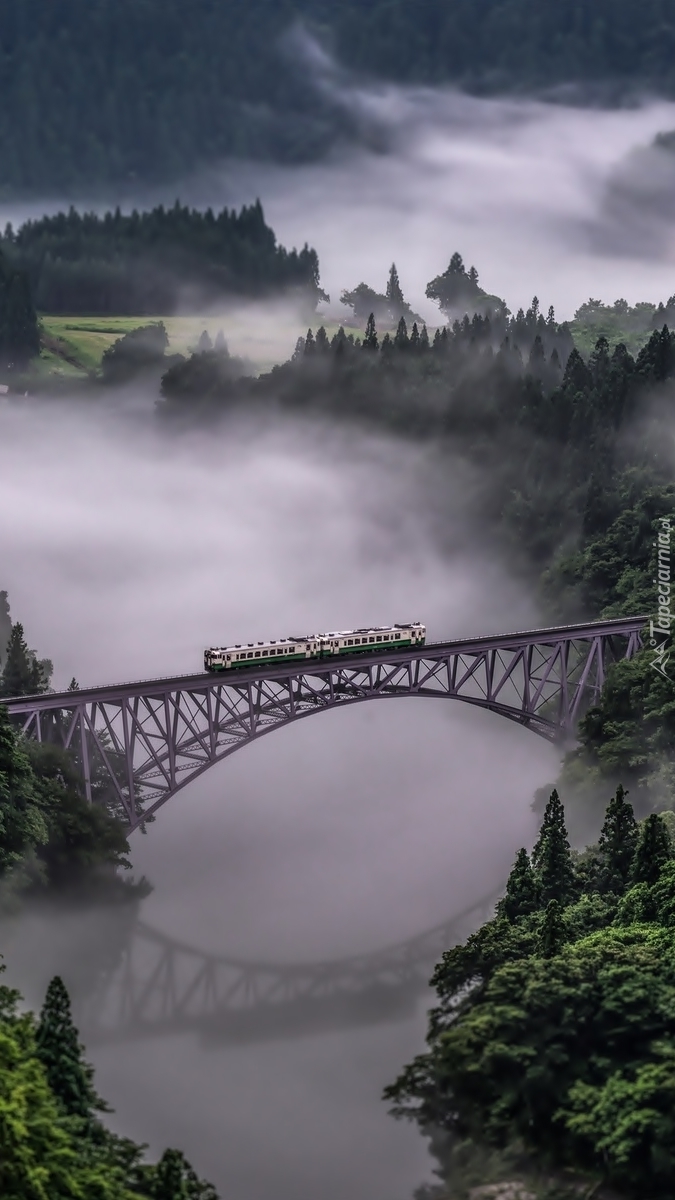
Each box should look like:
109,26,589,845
204,620,426,671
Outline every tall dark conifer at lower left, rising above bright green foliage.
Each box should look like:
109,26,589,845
35,976,106,1122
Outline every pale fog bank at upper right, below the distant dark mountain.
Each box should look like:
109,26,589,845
210,89,675,323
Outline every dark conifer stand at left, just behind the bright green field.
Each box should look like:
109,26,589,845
0,200,327,316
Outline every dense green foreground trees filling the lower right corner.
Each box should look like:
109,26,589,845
386,793,675,1198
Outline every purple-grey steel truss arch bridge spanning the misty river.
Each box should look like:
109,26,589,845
2,617,649,832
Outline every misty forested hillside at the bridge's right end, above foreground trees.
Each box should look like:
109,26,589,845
157,272,675,838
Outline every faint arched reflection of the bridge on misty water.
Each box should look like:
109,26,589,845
70,894,496,1045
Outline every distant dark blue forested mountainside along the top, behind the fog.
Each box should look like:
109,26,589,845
0,0,675,190
